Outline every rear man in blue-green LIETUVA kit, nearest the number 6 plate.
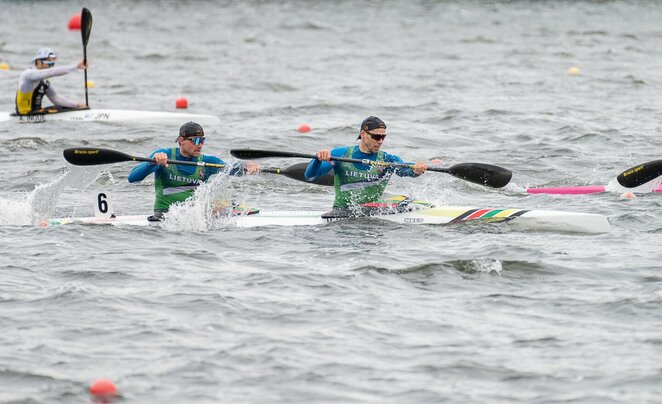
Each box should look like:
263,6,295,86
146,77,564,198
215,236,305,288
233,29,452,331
129,122,260,221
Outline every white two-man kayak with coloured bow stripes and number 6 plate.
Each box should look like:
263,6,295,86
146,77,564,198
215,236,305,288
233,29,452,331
41,206,611,233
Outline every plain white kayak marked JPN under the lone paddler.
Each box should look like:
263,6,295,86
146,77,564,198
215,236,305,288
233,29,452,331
0,108,221,126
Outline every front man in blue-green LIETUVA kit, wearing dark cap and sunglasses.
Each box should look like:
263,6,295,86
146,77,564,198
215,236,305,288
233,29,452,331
304,116,427,210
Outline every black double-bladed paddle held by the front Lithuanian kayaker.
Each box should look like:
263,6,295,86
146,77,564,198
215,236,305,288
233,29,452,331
230,149,513,188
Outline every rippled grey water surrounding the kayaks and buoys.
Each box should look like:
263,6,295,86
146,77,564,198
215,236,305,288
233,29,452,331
0,1,662,403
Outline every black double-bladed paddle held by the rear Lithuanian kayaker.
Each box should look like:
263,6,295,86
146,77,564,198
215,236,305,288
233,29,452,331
62,147,333,185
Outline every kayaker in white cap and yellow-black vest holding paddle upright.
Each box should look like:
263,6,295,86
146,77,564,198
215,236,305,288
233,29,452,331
16,48,88,115
